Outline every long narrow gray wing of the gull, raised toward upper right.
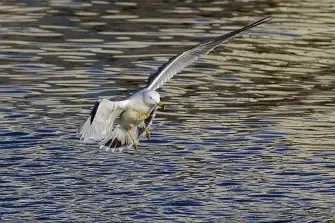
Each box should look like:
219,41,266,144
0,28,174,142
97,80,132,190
146,16,271,90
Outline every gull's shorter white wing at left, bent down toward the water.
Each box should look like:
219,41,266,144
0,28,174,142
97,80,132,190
79,99,129,141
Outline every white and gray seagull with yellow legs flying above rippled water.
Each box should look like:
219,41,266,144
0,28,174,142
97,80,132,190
79,16,271,151
